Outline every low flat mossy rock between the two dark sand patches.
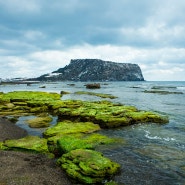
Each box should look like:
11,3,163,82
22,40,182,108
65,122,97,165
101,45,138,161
3,136,49,154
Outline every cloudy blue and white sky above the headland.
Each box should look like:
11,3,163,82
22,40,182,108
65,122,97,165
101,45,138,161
0,0,185,81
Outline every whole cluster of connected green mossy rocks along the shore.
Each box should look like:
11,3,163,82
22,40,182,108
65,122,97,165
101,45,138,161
0,91,168,184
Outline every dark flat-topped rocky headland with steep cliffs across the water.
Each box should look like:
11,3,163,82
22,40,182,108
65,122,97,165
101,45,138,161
37,59,144,81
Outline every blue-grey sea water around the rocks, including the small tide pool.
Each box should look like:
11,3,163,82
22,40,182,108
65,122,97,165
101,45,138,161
0,81,185,185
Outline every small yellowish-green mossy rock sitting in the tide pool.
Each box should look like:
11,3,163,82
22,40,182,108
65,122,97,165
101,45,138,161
26,116,53,128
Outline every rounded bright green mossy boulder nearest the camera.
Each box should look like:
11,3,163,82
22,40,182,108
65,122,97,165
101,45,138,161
57,149,120,184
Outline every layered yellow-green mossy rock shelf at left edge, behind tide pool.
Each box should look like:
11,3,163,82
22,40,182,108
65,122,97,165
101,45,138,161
0,91,60,116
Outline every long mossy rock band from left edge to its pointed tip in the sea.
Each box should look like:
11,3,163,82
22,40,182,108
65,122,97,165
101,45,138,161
0,91,168,128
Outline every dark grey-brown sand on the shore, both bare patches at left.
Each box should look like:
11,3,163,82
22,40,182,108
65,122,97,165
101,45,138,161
0,117,74,185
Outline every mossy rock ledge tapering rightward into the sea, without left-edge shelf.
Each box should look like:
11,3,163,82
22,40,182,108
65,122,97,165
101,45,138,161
57,100,168,128
